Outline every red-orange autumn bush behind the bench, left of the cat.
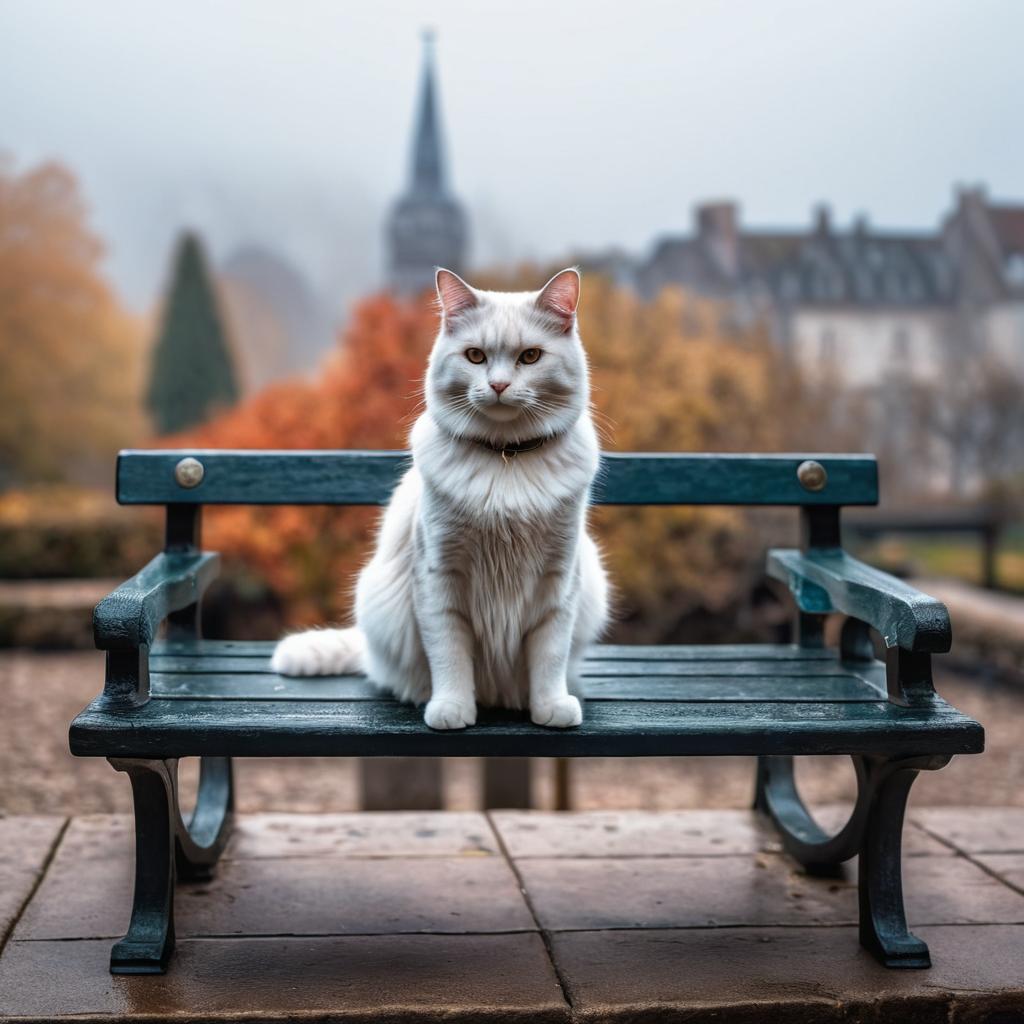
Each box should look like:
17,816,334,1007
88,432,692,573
175,295,437,625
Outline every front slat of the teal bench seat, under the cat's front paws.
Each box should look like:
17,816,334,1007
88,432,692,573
71,697,983,758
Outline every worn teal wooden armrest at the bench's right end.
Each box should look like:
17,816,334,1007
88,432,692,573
768,548,952,654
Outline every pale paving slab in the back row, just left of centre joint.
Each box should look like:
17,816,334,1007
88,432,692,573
224,812,499,859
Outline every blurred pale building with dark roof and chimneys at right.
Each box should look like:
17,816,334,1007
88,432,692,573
610,188,1024,388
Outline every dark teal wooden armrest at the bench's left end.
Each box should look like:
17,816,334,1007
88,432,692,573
92,551,220,650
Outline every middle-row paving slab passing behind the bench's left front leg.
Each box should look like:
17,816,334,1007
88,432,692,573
14,857,536,939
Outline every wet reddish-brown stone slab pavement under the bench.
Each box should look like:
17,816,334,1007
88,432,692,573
0,806,1024,1024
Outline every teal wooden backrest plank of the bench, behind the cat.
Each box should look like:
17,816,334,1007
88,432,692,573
118,450,879,506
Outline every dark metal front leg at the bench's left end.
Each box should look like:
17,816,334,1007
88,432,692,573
110,758,175,974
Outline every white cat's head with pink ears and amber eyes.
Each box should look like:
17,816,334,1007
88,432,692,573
426,269,589,442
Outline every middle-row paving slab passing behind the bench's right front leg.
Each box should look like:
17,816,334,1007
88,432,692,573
517,853,1024,931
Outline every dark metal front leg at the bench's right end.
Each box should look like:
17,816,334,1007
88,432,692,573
857,757,950,968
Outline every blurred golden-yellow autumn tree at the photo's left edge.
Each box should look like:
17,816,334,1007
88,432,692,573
0,162,143,485
